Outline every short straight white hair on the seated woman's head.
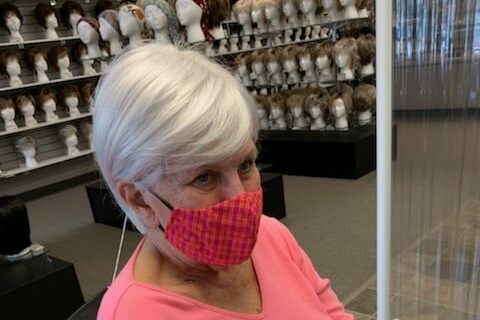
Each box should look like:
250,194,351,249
93,43,259,234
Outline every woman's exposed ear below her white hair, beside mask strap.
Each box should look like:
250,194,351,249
116,181,160,228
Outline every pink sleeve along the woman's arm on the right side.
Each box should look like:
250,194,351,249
279,223,353,320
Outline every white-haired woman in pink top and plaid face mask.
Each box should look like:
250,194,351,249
93,44,352,320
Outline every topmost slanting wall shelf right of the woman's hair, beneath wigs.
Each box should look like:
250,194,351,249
206,18,375,57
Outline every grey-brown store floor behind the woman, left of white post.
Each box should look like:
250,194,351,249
27,173,375,306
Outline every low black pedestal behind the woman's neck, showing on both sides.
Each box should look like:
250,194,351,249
86,172,286,230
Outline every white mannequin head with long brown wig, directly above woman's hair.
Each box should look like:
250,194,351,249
143,0,180,43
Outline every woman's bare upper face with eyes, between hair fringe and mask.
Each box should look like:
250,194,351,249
155,140,261,208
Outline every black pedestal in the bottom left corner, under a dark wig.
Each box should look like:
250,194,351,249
0,255,84,320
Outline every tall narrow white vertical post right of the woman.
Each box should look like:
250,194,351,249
375,0,393,320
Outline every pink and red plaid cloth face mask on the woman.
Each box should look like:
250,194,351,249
157,188,263,267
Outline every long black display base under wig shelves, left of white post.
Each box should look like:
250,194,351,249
258,125,376,179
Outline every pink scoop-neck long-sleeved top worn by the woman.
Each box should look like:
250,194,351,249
97,216,353,320
